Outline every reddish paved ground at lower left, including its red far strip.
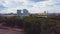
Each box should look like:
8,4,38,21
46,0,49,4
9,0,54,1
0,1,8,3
0,27,25,34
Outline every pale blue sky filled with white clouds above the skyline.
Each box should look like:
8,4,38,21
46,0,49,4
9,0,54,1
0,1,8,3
0,0,60,13
